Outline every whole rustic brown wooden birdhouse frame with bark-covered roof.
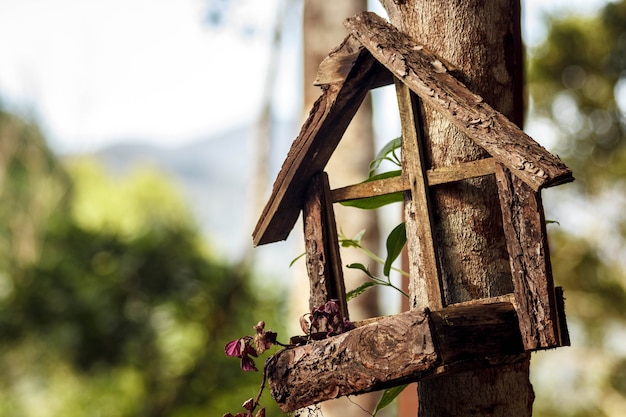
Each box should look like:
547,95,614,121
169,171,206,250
253,12,573,411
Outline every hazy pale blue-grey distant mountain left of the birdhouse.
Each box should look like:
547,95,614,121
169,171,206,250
88,120,297,263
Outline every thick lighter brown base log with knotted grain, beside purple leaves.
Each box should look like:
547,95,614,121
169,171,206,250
266,310,439,412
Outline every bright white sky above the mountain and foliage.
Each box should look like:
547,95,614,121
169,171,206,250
0,0,601,152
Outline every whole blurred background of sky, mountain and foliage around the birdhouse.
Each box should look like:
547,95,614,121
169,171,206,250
0,0,626,417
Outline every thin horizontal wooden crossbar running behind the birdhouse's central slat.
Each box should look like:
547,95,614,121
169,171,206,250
331,158,495,203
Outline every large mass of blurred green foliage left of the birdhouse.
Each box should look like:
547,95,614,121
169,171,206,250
0,112,280,417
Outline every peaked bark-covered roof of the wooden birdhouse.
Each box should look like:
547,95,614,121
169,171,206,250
253,12,573,246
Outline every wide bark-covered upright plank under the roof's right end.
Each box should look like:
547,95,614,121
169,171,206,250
496,164,563,351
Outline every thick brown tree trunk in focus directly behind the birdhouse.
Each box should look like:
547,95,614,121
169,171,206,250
381,0,534,417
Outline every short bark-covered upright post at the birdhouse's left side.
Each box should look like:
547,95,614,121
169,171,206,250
302,172,349,318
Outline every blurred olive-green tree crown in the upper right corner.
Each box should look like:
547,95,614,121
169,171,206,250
528,1,626,187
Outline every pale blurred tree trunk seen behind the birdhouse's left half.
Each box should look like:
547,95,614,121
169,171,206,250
298,0,379,417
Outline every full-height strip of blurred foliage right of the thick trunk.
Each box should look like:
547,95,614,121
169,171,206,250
528,0,626,417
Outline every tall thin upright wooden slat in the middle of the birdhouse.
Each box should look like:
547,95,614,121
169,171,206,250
396,81,443,309
